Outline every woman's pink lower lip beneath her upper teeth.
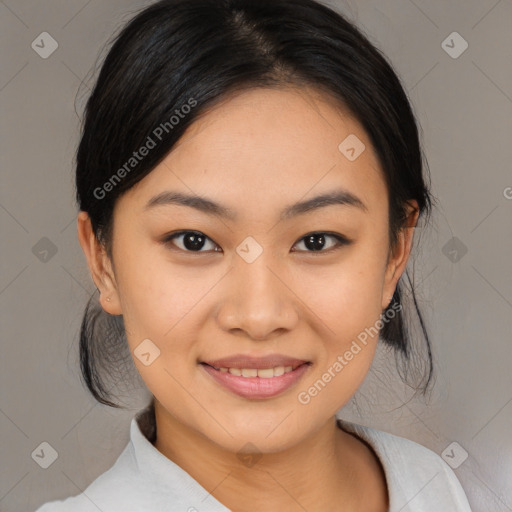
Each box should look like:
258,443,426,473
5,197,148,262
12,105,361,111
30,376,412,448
201,363,310,398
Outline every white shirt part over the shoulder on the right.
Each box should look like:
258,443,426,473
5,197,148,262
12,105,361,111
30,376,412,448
338,420,471,512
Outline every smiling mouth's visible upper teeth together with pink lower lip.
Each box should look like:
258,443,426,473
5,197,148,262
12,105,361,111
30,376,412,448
200,361,312,399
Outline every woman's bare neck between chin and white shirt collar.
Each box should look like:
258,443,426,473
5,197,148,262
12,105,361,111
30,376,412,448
150,402,387,512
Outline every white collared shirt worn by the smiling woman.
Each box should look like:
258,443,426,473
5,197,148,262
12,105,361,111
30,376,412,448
36,405,471,512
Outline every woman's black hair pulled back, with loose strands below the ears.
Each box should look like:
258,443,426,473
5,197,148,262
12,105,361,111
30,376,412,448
76,0,434,407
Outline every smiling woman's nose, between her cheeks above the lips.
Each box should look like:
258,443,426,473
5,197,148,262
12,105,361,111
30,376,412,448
217,255,299,341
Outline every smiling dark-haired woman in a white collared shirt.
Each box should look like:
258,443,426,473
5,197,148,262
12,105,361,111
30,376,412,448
39,0,470,512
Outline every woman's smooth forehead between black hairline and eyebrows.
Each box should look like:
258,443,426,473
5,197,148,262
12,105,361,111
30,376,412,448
121,88,386,215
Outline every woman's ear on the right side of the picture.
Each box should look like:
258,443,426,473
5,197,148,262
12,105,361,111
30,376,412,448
382,200,419,310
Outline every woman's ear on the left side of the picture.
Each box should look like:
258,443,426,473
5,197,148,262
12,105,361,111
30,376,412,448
77,211,122,315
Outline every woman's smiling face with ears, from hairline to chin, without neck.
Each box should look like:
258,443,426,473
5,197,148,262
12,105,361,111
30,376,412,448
79,89,412,452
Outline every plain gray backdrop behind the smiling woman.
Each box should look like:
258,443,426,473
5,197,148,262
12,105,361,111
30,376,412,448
0,0,512,512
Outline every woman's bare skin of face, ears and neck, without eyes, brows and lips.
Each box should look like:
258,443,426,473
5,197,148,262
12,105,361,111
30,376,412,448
78,88,418,512
